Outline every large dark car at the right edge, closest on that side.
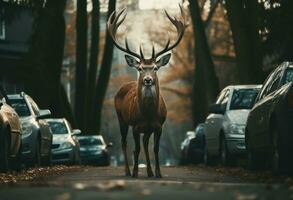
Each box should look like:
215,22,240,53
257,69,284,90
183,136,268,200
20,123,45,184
245,62,293,172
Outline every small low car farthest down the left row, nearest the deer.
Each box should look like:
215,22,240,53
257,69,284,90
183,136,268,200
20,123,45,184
78,135,112,166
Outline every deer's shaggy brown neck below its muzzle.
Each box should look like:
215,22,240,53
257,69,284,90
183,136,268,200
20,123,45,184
137,81,160,117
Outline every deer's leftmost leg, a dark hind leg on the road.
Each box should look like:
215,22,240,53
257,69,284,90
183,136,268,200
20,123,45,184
119,120,131,176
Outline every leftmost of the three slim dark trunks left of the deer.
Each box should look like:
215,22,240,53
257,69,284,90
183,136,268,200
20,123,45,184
74,0,87,129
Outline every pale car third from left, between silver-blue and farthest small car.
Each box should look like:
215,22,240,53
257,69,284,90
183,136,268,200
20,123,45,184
47,118,81,164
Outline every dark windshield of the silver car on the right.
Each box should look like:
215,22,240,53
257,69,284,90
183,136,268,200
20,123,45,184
230,89,259,110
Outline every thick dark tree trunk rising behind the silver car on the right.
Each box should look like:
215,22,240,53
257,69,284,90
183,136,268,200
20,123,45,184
225,0,264,84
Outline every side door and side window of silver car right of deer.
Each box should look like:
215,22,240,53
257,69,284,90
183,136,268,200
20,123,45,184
205,89,229,155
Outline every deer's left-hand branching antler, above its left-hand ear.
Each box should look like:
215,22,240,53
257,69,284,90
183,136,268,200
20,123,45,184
107,8,141,59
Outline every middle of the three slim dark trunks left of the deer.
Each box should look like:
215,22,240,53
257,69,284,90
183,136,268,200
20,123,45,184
85,0,100,132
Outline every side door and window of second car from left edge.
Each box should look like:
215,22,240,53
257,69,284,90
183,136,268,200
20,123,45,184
28,97,52,155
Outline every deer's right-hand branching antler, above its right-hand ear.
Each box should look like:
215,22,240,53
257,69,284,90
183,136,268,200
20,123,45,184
153,4,188,59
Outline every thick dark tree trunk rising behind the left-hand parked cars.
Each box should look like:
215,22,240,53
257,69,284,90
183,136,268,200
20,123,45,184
23,0,74,124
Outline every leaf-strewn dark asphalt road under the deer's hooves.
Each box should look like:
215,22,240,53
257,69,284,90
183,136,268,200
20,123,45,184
0,166,293,200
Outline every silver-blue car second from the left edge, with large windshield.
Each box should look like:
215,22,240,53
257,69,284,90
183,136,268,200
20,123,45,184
8,92,52,167
